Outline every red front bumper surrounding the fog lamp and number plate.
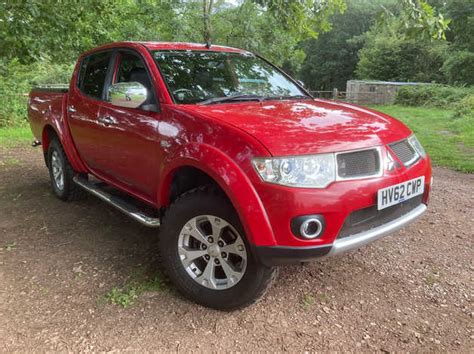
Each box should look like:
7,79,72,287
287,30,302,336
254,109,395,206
253,153,431,248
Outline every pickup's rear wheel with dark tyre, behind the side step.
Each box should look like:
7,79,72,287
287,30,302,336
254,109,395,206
48,139,86,201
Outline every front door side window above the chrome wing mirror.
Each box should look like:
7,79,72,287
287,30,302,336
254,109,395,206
115,52,156,106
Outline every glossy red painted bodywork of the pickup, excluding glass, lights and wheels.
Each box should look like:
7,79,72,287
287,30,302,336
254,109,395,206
29,42,431,246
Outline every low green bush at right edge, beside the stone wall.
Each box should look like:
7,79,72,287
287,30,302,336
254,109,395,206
395,85,474,108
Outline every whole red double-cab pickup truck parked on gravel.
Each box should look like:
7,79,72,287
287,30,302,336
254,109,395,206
28,42,432,309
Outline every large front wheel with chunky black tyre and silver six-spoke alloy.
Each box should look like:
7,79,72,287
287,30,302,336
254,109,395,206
160,187,277,310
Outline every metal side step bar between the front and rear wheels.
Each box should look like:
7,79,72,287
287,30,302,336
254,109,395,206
74,176,160,227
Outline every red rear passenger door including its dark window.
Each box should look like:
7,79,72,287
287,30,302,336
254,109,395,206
67,50,113,174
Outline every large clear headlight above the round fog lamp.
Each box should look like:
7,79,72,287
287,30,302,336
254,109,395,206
252,154,336,188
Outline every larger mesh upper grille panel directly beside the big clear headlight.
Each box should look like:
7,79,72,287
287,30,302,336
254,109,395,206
337,149,380,178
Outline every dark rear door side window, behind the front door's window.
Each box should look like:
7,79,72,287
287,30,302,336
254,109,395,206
79,52,111,99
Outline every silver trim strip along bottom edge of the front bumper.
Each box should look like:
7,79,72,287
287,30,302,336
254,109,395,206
327,204,427,257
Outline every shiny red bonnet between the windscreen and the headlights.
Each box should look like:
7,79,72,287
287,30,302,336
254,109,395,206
176,100,410,156
